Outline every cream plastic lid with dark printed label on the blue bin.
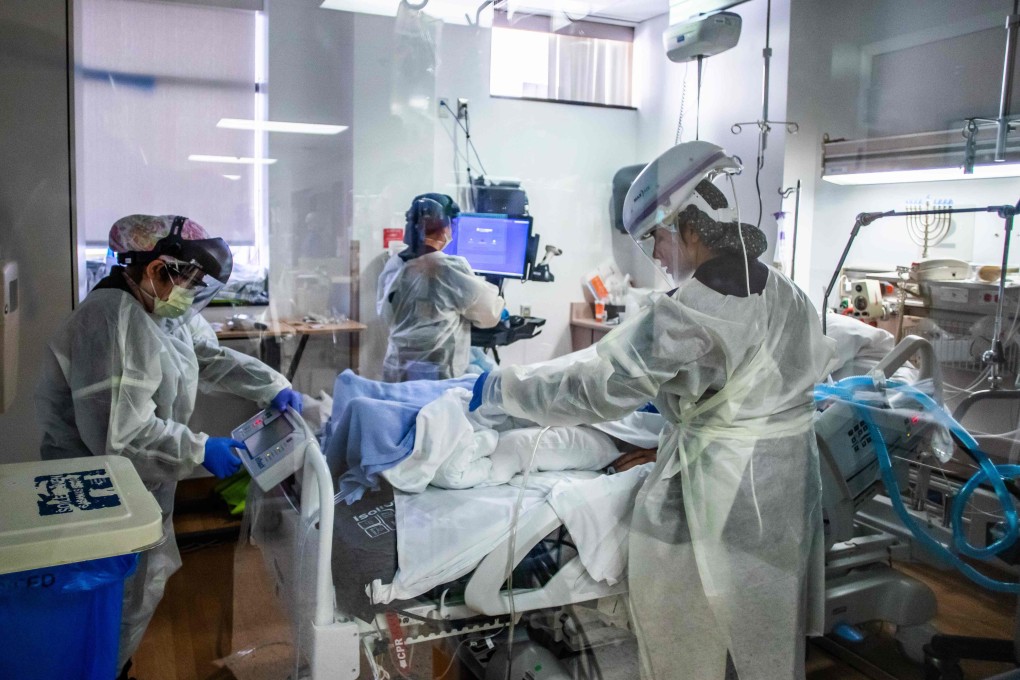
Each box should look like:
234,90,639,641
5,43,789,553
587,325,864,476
0,456,163,574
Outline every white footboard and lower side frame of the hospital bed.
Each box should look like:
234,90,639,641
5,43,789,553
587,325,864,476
244,448,626,680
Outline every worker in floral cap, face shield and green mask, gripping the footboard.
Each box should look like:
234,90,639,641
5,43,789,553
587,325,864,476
36,215,301,677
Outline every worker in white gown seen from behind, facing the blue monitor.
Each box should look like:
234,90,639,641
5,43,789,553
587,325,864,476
377,194,506,382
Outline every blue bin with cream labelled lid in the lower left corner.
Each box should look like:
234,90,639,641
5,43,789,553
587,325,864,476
0,456,163,680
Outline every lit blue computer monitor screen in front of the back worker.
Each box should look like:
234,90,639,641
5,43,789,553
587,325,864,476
445,212,531,278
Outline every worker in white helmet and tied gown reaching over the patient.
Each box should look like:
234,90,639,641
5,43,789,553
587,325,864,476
472,142,834,680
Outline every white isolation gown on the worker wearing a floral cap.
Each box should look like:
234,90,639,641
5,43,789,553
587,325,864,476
36,277,290,665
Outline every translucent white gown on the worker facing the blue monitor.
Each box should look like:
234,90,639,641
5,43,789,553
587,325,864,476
383,252,504,382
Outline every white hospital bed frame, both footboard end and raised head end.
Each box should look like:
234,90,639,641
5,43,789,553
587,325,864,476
236,337,987,680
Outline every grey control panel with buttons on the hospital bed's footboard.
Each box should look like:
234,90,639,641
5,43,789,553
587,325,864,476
232,409,314,491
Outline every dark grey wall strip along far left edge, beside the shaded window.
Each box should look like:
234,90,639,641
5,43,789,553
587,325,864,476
0,0,74,463
